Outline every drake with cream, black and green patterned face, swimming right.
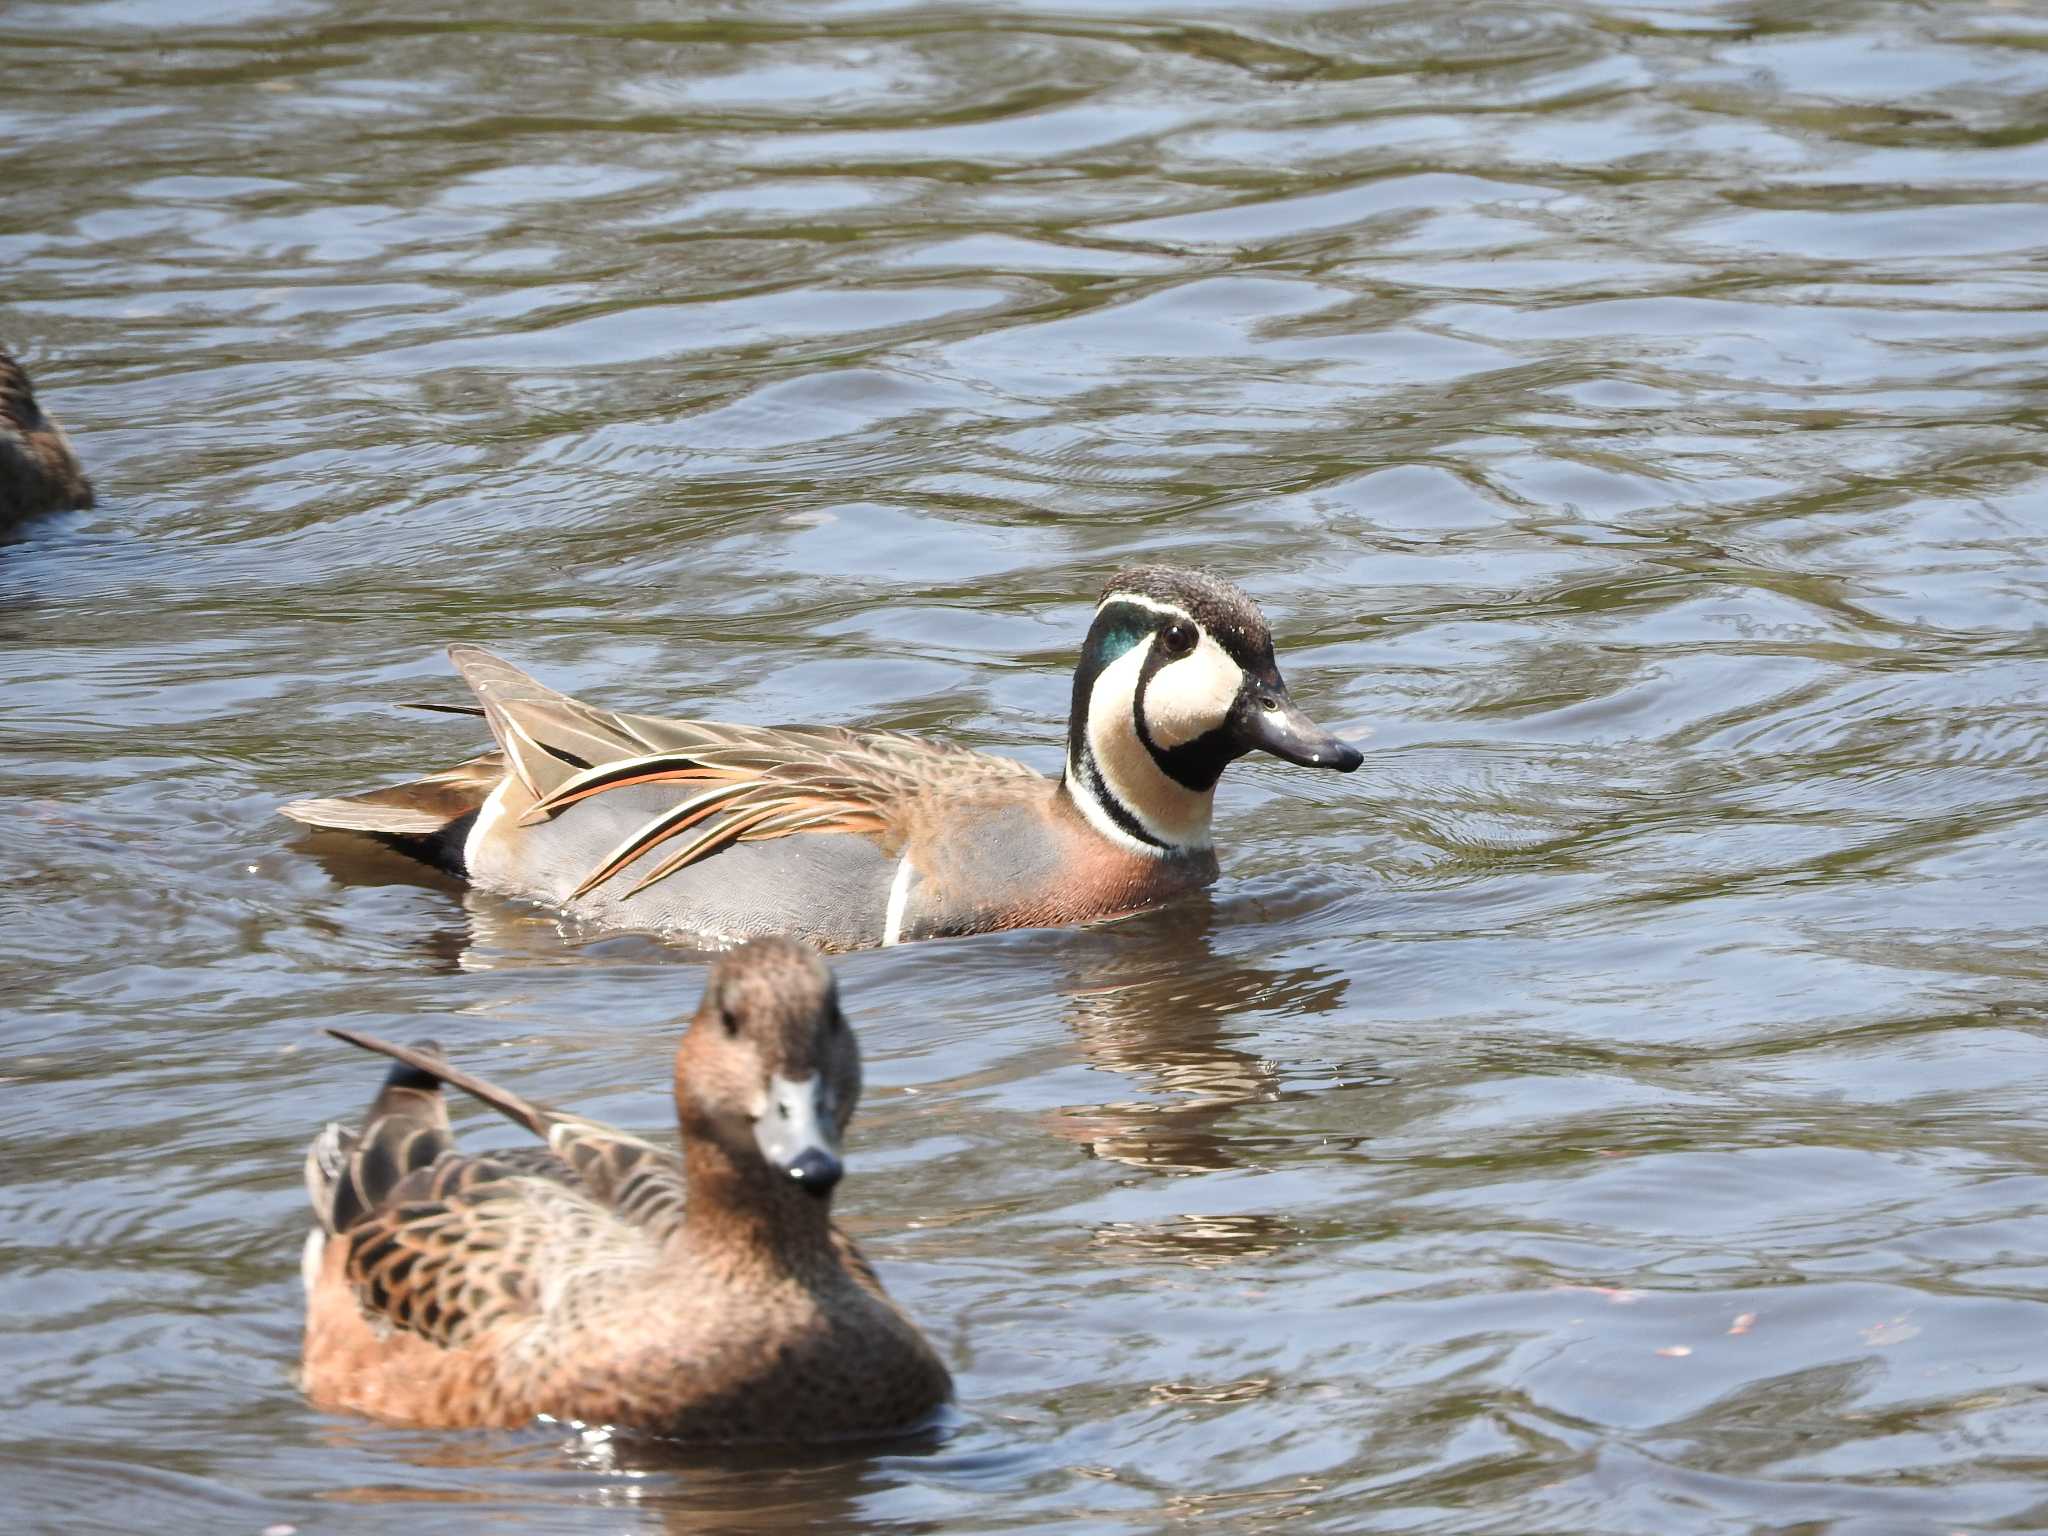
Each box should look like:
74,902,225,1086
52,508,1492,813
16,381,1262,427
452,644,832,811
283,565,1360,950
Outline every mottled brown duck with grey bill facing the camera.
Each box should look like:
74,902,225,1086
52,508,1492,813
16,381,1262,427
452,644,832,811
303,938,952,1442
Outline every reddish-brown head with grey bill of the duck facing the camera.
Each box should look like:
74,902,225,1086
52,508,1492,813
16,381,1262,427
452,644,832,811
676,938,860,1198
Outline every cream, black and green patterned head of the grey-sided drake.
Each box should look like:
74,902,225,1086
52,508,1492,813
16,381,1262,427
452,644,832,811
1067,565,1364,852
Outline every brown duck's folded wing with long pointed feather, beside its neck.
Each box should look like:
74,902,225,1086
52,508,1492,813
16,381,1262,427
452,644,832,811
328,1028,684,1239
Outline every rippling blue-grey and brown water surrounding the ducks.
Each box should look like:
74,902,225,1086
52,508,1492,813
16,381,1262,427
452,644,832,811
0,0,2048,1536
